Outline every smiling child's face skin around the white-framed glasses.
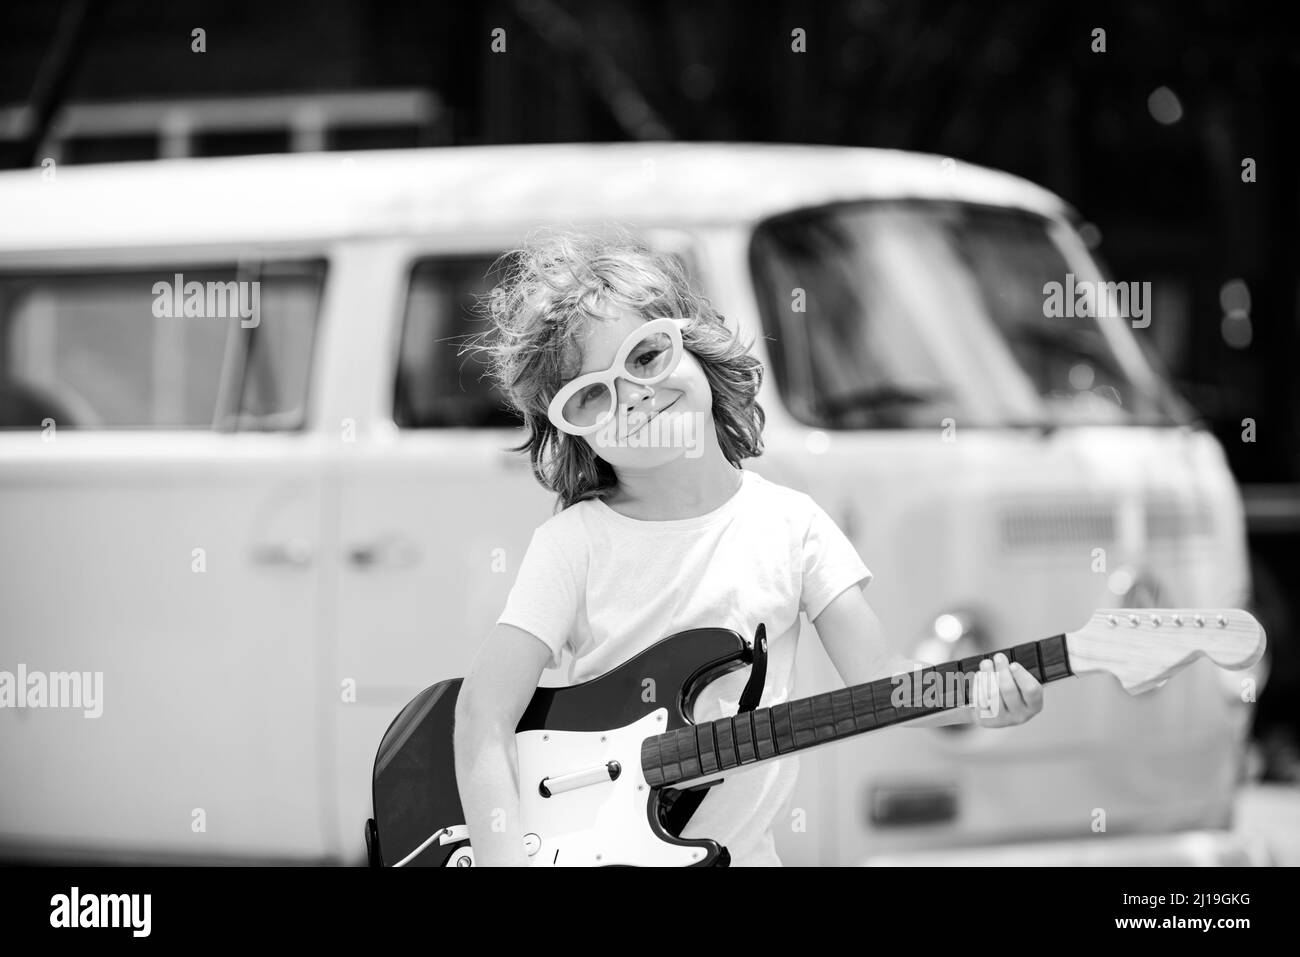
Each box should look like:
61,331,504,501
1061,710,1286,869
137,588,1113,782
579,309,714,469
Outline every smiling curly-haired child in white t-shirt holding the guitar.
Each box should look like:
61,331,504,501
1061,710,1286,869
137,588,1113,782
455,223,1041,867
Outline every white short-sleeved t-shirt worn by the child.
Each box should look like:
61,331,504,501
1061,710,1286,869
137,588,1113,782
497,471,871,867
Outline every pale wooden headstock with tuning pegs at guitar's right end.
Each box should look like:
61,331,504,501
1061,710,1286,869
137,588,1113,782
1066,609,1266,694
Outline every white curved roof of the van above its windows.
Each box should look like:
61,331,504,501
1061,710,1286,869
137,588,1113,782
0,142,1066,252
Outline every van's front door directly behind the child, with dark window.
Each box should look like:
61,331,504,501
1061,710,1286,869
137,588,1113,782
322,241,554,862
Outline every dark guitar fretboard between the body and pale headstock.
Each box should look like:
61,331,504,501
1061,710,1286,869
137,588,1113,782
641,635,1073,787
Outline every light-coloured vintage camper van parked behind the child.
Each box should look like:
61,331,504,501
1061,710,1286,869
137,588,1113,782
0,143,1249,865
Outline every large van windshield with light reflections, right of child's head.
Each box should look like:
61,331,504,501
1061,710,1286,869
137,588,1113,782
750,200,1179,429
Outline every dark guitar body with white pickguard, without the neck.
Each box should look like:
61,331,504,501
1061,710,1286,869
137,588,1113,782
367,628,751,867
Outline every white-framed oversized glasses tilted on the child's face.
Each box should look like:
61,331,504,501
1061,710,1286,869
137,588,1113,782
547,316,684,436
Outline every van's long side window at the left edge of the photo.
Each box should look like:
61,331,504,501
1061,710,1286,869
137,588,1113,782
0,263,324,429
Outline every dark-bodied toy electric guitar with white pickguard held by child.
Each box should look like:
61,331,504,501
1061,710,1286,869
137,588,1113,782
365,609,1265,867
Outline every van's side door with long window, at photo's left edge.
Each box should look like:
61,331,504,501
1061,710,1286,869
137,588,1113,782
0,257,325,862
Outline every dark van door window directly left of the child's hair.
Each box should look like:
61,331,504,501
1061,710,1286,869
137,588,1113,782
393,256,523,429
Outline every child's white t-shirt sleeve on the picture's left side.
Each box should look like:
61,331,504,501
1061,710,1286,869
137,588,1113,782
497,525,579,668
